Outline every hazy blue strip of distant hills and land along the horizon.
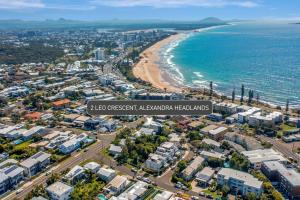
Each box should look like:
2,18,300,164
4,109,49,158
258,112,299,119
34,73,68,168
0,17,226,30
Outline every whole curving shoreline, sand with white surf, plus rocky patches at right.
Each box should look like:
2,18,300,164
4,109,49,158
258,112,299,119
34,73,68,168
132,24,299,108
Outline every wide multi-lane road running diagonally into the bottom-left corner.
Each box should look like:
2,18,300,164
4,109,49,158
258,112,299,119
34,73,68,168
2,135,113,200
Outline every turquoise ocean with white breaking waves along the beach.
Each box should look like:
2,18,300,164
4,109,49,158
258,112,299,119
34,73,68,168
162,23,300,106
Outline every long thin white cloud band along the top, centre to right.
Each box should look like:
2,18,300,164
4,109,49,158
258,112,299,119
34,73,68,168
91,0,259,8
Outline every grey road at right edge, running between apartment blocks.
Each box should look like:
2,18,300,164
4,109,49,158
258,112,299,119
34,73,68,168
258,135,300,165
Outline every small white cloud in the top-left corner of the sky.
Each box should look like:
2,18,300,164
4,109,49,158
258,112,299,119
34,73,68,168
0,0,45,9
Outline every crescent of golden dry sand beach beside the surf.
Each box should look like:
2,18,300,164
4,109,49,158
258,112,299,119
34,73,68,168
133,33,184,92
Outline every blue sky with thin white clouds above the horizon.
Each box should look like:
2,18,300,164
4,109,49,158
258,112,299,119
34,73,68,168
0,0,300,20
